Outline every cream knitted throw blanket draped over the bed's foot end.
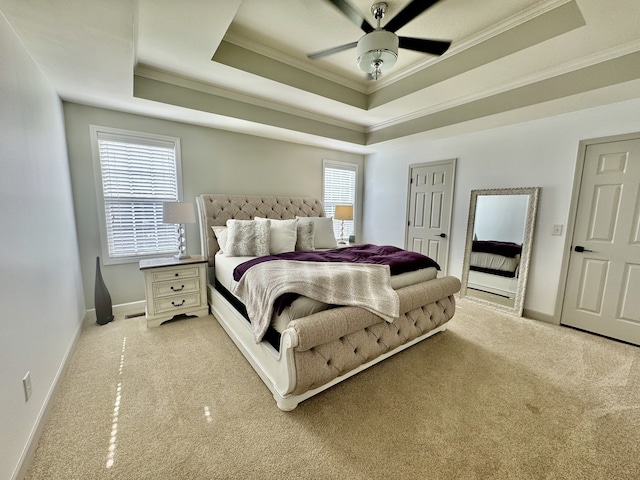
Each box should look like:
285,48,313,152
233,260,400,342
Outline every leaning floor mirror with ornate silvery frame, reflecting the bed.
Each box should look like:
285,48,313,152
460,187,540,316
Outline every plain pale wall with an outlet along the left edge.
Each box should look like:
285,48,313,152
0,14,85,479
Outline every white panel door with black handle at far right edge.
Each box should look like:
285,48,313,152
561,140,640,345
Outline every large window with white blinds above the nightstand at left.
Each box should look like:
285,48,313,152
91,125,181,264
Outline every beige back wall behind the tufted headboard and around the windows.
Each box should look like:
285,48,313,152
64,103,364,308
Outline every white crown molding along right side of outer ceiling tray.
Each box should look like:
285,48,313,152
367,40,640,133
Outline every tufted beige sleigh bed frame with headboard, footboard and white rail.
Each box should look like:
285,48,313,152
196,194,460,411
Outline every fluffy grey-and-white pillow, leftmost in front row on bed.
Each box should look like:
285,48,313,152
224,220,271,257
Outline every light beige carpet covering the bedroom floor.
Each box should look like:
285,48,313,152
22,301,640,480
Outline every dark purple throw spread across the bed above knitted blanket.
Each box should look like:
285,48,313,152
233,244,440,282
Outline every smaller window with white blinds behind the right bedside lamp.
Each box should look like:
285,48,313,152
322,160,358,238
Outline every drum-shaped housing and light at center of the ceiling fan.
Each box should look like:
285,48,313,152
358,30,399,80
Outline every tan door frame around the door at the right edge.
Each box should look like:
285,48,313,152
552,132,640,325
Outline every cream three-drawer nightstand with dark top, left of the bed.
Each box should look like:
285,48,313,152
140,255,209,327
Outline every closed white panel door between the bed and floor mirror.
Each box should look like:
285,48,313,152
405,160,456,275
